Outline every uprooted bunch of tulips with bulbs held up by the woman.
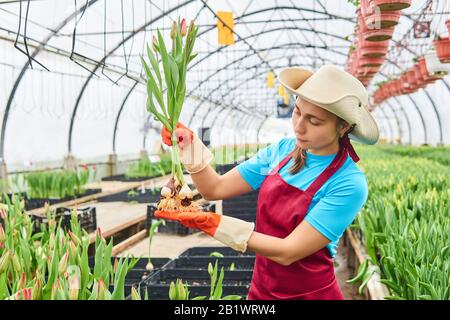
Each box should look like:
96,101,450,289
141,19,198,211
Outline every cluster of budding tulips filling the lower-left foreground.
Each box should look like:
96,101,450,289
0,197,137,300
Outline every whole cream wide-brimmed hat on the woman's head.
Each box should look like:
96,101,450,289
278,65,379,144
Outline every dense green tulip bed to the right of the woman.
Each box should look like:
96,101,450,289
354,146,450,300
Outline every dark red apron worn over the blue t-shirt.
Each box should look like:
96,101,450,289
248,142,352,300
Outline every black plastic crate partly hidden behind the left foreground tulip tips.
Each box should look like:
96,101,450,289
30,207,97,233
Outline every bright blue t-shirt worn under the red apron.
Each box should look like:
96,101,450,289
237,138,368,258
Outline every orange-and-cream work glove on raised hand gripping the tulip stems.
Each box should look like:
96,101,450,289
161,122,214,173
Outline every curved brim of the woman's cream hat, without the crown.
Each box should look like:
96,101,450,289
278,67,379,145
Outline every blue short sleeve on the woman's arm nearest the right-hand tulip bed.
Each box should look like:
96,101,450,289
305,172,368,241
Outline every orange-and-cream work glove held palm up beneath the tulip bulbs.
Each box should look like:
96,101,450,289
155,210,255,252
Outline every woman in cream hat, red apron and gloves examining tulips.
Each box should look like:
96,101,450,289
157,65,379,299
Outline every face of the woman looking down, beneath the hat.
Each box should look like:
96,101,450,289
292,98,348,150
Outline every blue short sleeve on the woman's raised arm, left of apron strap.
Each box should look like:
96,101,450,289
236,139,284,190
